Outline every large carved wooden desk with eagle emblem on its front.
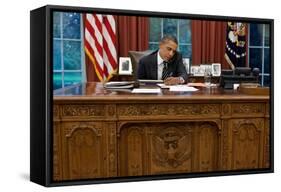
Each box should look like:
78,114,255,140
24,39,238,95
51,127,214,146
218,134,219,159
53,83,270,181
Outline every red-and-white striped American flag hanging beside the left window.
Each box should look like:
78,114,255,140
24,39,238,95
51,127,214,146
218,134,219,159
84,14,117,82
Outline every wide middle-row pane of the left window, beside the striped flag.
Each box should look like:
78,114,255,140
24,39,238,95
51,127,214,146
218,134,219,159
63,41,81,70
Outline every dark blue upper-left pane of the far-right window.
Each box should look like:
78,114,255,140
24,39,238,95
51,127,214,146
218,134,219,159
250,24,263,46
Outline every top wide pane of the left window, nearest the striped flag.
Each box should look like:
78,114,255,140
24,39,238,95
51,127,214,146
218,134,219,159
63,13,80,39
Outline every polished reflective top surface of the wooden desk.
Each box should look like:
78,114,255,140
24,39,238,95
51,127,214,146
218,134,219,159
53,82,270,101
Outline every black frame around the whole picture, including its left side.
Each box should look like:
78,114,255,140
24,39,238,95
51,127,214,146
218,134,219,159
30,5,274,187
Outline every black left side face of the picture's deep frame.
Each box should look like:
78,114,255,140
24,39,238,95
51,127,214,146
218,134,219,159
30,7,48,185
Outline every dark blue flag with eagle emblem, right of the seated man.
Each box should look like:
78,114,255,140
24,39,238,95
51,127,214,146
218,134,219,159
224,22,246,69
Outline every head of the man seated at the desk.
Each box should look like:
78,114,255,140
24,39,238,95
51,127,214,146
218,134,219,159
159,35,178,61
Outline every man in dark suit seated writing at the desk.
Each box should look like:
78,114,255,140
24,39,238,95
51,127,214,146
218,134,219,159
138,35,187,85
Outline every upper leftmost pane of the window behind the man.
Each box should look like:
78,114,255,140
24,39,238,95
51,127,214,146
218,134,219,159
149,18,162,42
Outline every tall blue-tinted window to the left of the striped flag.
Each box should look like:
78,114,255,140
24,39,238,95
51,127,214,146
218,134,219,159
53,12,85,89
